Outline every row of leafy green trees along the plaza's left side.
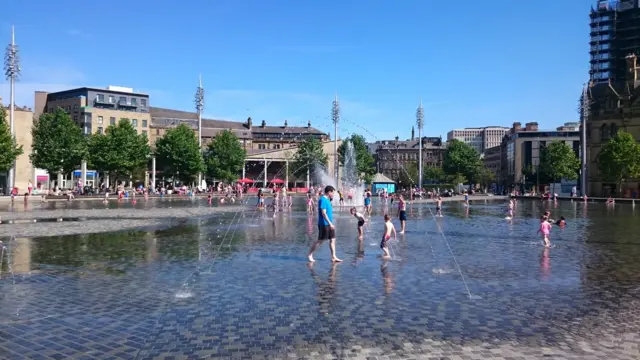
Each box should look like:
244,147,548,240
0,108,246,187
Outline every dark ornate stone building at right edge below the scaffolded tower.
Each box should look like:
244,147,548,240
586,55,640,196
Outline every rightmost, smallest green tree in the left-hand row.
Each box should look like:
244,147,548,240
205,130,247,182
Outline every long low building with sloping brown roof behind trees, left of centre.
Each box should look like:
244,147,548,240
149,107,329,150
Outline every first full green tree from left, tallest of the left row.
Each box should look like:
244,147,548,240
29,108,87,185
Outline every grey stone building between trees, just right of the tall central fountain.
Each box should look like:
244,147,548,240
372,132,447,183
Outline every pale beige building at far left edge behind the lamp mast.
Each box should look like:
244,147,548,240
0,97,38,194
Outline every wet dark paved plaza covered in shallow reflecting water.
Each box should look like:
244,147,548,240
0,199,640,359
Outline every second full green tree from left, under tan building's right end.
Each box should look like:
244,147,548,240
89,118,151,183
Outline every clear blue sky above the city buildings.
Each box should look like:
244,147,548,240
0,0,593,141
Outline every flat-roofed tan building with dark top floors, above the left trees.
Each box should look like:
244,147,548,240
34,86,151,134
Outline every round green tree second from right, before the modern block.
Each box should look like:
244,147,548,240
540,141,580,192
